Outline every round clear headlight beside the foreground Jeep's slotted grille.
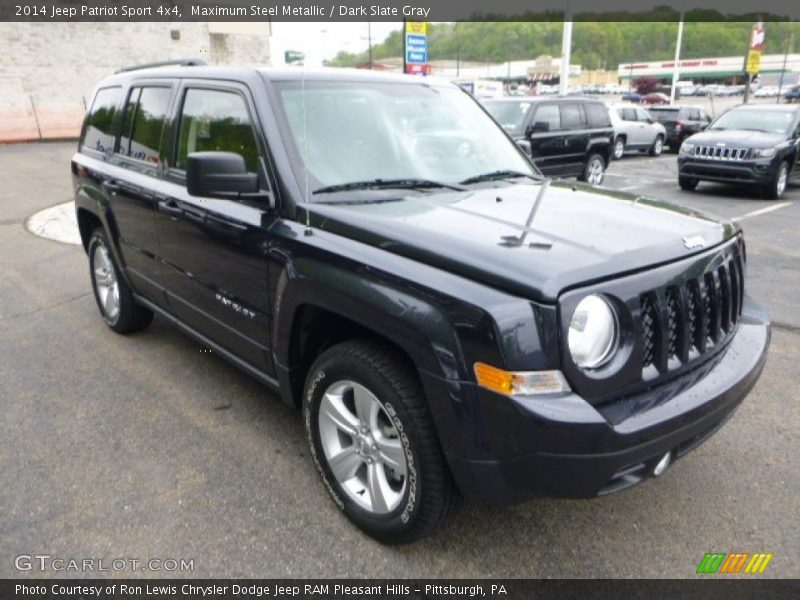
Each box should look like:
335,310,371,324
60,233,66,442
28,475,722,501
568,294,619,369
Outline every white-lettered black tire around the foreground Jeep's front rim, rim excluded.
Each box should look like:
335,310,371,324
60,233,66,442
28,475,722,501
303,340,459,544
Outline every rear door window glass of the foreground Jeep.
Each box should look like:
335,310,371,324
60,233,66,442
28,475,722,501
118,87,172,165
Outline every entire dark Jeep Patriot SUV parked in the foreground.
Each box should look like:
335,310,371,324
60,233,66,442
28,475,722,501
71,66,769,542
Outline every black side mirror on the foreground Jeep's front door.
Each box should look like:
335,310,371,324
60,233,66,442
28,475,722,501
186,152,258,197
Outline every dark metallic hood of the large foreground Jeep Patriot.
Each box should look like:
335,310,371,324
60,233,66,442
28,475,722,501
310,182,737,302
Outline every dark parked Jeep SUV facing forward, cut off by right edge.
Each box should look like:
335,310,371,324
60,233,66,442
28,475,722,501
678,104,800,200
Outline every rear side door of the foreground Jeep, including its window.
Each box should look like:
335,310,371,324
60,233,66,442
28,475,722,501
108,80,176,306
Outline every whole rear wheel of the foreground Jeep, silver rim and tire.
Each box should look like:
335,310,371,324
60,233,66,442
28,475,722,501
88,227,153,333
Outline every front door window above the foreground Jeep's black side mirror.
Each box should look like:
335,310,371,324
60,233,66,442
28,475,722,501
175,89,258,173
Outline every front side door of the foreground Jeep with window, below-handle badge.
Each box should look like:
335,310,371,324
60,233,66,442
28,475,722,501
156,81,277,372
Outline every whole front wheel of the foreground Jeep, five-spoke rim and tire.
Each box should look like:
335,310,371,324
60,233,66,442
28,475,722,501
303,341,457,544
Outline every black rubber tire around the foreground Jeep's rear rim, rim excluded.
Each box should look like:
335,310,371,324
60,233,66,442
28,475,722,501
88,227,153,333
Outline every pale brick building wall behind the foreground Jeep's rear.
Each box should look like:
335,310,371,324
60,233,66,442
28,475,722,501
0,22,270,142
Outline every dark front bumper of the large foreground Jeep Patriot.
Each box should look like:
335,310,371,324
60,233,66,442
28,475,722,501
428,298,770,505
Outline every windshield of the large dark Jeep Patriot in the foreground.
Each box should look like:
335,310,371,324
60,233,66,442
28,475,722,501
276,81,537,192
